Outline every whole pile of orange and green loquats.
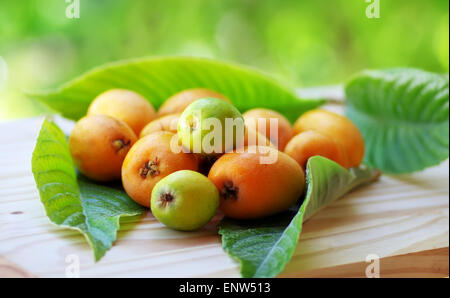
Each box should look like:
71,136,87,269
69,89,364,231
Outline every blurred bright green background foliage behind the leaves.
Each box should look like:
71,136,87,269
0,0,449,120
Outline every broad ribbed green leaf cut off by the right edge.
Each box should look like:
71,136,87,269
345,68,449,174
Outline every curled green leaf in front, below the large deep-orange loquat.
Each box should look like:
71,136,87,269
219,156,379,277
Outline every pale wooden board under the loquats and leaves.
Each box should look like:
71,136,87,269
0,118,449,277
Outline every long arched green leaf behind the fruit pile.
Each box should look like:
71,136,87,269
29,57,324,121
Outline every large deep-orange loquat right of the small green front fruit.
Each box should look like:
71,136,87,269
208,146,305,219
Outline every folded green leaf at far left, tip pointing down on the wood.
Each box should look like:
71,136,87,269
32,120,144,261
